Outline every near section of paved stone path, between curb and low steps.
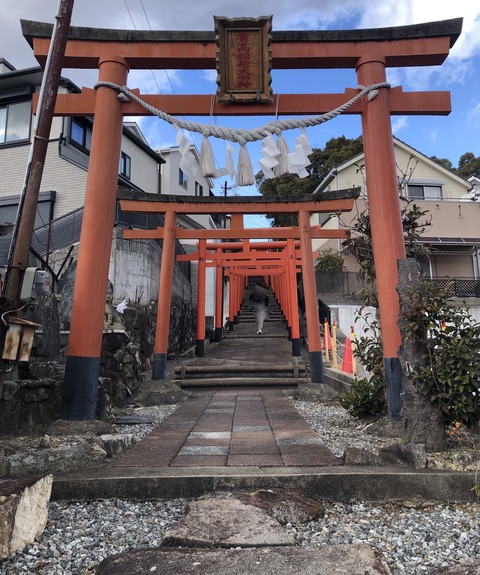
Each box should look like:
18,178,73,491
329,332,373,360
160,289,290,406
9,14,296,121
113,389,341,468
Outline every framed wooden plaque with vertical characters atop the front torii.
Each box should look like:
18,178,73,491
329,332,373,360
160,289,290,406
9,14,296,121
214,16,273,103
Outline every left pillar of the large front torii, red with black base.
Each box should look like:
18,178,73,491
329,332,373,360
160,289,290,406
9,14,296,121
62,56,128,421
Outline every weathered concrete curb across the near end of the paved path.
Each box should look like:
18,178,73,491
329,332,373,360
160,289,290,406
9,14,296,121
52,466,476,502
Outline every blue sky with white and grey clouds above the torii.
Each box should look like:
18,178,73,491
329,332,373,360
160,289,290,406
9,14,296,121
0,0,480,201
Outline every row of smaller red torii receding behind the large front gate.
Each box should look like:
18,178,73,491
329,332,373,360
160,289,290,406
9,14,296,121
116,190,358,383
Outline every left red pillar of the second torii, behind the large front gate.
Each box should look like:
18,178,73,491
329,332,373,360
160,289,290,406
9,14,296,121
152,210,177,380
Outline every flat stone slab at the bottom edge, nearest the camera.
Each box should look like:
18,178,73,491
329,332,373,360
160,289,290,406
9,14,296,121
95,545,391,575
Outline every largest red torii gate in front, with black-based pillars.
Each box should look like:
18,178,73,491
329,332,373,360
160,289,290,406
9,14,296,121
20,15,462,419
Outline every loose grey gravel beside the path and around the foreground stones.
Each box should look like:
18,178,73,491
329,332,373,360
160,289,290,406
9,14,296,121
0,401,480,575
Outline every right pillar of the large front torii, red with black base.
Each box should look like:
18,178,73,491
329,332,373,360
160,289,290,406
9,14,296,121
357,56,405,419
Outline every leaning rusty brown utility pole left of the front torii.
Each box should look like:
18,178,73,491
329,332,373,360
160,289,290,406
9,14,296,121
5,0,74,308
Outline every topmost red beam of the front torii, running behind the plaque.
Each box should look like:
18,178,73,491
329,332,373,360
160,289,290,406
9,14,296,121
24,27,458,70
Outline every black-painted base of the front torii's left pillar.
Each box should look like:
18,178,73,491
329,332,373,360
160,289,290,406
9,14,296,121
62,356,100,421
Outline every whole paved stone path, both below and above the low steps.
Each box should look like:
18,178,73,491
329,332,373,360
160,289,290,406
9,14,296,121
109,284,342,468
